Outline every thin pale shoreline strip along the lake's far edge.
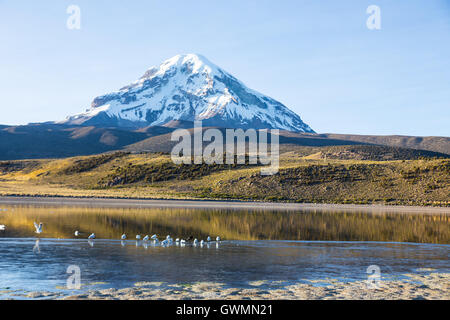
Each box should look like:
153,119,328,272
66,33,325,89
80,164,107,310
0,196,450,214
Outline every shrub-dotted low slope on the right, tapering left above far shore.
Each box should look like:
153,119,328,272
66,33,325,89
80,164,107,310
207,160,450,206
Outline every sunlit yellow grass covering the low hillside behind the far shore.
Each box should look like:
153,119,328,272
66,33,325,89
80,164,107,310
0,152,450,206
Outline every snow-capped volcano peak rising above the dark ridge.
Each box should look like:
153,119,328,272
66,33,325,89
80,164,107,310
65,54,313,132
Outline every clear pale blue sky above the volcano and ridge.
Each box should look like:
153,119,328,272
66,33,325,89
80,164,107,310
0,0,450,136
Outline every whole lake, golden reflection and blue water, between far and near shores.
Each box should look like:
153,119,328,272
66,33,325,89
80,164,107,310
0,206,450,298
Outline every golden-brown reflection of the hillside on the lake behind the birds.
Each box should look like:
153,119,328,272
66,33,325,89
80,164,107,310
0,206,450,245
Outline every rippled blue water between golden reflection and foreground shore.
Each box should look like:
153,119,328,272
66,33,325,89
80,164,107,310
0,238,450,297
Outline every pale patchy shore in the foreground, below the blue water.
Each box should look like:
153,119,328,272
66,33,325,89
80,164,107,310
0,270,450,300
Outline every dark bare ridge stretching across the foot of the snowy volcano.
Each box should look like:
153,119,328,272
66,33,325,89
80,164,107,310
0,122,450,160
